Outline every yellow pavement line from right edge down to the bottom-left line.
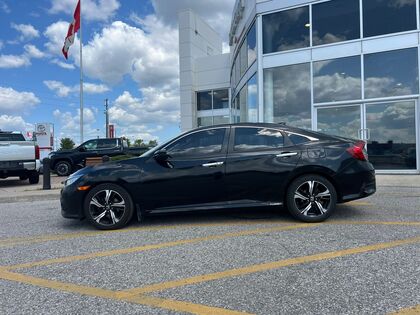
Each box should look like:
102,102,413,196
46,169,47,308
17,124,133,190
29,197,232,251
118,236,420,297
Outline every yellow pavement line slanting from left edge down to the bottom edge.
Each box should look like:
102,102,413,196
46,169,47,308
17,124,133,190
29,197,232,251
0,268,247,315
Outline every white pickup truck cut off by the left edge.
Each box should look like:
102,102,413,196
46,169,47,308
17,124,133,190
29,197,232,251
0,131,41,184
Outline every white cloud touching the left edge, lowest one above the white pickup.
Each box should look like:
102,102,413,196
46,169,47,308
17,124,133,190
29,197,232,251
0,86,40,113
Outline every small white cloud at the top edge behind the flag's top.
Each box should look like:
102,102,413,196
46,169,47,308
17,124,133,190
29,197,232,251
49,0,120,22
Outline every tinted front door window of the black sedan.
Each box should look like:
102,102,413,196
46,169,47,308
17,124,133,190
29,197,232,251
166,128,226,156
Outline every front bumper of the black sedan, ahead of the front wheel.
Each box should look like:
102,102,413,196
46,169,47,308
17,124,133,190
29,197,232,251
60,185,86,219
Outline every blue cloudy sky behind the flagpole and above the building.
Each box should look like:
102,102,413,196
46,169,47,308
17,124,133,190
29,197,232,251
0,0,235,143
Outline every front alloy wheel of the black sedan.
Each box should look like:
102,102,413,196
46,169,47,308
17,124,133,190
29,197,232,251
89,189,126,226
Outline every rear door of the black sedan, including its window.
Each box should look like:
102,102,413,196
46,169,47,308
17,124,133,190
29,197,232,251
226,126,301,204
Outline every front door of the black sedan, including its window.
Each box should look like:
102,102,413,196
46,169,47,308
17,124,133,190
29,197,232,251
141,127,230,209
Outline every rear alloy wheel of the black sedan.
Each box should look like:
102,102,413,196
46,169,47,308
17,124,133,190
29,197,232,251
294,180,331,217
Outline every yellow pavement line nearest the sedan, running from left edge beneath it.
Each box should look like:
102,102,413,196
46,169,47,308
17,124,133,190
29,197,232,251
0,219,293,247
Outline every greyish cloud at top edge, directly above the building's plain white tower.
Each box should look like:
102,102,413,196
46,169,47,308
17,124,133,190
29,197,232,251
152,0,235,41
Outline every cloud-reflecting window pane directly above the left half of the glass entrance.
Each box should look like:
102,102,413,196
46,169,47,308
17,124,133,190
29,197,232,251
313,56,362,103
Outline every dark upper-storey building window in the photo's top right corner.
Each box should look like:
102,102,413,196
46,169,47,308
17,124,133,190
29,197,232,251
363,0,417,37
